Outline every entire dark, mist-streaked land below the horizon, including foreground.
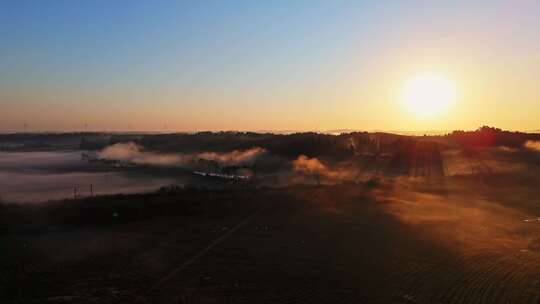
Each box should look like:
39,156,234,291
0,127,540,304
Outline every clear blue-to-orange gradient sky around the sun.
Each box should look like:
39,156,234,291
0,0,540,131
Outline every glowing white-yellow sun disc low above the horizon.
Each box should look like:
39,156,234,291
402,73,456,117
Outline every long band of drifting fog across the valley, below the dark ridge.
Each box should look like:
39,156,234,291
4,141,540,202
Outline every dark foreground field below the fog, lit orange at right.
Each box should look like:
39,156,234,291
0,175,540,303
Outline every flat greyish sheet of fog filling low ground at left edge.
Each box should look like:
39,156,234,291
0,152,185,202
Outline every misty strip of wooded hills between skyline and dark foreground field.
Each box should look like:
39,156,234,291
0,130,540,202
